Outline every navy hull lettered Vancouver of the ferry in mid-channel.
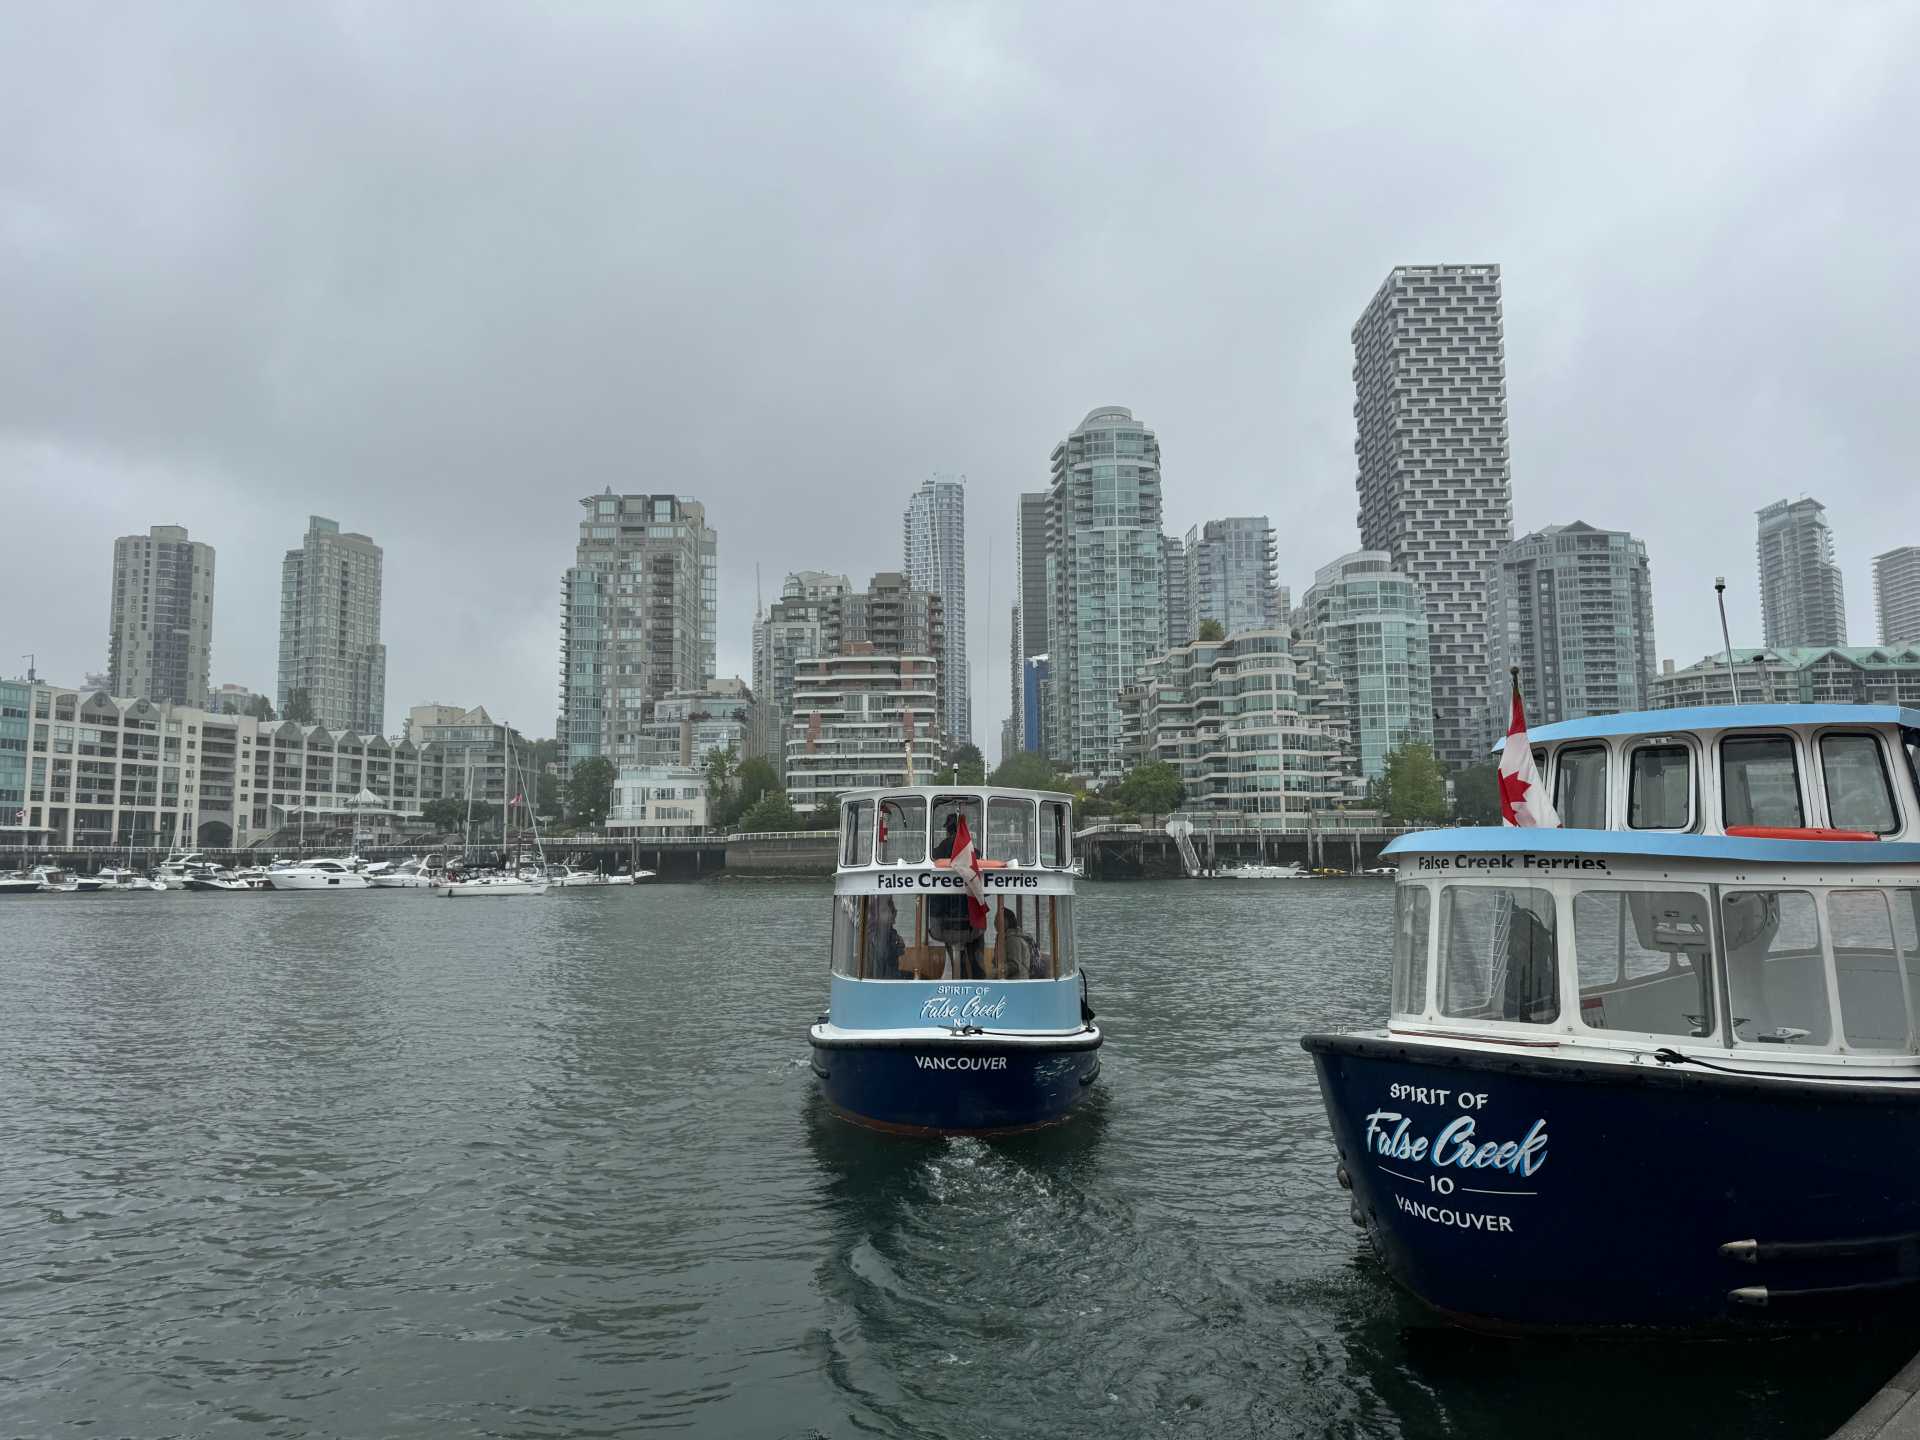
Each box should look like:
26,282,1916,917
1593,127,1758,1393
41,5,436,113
812,1035,1100,1135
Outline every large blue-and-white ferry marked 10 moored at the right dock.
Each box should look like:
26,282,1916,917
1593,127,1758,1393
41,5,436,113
1302,705,1920,1331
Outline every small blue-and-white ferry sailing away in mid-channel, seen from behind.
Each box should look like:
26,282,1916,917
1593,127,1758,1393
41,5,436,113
810,785,1100,1135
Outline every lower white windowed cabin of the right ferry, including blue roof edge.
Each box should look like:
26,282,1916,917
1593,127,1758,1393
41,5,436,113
1390,833,1920,1066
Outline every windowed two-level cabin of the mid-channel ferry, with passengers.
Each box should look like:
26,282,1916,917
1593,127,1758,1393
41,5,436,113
833,785,1077,983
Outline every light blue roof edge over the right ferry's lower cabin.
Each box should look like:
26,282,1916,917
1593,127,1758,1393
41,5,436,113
1380,821,1920,876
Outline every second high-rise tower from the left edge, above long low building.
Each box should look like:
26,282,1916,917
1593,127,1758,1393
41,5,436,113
275,515,386,735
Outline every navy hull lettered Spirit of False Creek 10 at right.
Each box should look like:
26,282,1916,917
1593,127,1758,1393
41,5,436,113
1304,1035,1920,1332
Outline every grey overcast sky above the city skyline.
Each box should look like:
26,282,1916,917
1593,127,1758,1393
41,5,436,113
0,0,1920,756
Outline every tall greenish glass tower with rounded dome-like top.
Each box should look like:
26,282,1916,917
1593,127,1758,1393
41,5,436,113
1046,405,1167,780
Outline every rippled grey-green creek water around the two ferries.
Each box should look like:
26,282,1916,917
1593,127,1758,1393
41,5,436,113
0,881,1905,1440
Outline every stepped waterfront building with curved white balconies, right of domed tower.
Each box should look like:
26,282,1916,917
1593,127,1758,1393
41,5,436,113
1119,624,1359,831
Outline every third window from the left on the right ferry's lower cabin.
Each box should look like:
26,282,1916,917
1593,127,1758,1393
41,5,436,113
1572,891,1713,1039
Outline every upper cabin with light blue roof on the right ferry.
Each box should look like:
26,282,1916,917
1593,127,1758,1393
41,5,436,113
1505,705,1920,841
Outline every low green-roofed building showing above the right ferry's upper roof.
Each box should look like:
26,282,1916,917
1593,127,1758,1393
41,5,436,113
1647,645,1920,710
